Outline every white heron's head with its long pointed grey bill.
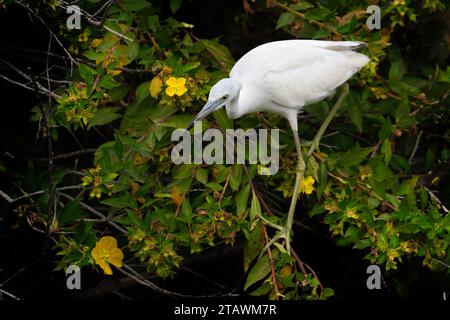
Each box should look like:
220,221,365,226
187,78,241,130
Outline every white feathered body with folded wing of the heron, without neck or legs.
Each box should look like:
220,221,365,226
230,40,369,109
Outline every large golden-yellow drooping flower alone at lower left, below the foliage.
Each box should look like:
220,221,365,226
91,236,123,275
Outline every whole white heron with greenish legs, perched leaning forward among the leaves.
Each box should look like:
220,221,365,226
188,40,369,254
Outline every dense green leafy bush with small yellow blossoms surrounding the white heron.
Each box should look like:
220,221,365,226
4,0,450,299
